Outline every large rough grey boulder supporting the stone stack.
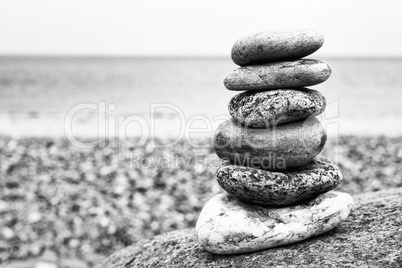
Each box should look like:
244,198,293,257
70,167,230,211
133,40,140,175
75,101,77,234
103,188,402,268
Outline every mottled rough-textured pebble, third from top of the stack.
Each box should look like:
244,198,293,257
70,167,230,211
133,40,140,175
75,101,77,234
228,88,326,128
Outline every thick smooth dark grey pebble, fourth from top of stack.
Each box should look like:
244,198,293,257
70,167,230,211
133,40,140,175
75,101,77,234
213,117,327,170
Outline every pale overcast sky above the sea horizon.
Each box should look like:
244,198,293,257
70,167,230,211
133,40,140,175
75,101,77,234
0,0,402,57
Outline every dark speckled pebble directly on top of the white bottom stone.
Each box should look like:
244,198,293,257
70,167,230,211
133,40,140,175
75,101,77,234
216,156,342,206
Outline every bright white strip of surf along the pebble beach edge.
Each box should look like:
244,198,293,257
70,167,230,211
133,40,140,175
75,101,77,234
0,112,402,139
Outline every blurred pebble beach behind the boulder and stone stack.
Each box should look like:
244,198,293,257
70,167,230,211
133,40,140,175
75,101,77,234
0,136,402,267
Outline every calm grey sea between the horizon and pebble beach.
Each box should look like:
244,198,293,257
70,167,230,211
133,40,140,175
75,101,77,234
0,55,402,136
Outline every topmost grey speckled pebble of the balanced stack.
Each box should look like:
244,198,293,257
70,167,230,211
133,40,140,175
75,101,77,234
232,29,324,66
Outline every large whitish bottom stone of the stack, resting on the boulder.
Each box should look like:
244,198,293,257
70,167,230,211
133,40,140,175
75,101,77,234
196,191,353,254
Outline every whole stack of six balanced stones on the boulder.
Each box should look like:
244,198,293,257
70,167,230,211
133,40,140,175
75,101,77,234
196,29,353,254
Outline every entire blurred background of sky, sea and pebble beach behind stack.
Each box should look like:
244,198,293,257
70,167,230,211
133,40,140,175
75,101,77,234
0,0,402,267
